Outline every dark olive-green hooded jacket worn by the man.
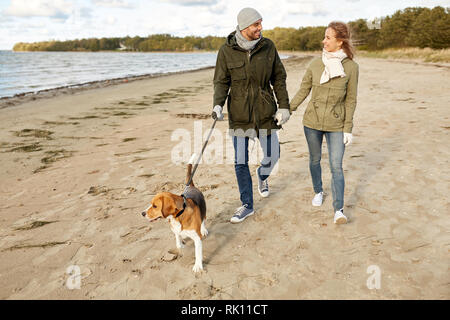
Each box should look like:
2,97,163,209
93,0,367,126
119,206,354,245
213,31,289,131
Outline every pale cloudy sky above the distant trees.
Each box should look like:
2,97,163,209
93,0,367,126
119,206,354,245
0,0,450,50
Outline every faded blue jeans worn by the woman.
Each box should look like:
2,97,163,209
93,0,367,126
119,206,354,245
304,127,345,211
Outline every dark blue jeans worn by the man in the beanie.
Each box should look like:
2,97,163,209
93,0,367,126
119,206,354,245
233,133,280,209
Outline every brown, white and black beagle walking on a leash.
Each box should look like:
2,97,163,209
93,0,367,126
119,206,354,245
142,154,208,272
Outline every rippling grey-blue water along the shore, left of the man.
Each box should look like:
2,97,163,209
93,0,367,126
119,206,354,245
0,51,217,97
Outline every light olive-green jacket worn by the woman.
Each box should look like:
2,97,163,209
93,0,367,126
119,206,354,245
291,58,359,133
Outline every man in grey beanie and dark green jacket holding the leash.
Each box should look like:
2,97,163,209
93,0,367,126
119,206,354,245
212,8,290,223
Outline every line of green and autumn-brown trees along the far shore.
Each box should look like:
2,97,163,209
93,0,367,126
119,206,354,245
13,6,450,52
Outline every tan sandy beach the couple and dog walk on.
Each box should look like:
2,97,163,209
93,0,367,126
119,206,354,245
0,55,450,299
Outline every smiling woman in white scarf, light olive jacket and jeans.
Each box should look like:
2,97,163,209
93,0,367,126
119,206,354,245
290,22,359,224
